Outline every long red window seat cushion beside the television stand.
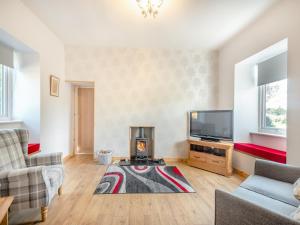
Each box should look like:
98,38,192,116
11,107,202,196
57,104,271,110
234,143,286,164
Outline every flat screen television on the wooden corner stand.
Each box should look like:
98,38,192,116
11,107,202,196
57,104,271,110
189,110,233,141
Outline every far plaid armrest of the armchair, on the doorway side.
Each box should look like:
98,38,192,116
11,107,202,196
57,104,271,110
25,152,62,167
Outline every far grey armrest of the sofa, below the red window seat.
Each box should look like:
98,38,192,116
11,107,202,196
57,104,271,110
254,159,300,184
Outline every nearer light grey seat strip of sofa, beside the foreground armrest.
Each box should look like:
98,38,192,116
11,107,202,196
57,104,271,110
232,187,297,217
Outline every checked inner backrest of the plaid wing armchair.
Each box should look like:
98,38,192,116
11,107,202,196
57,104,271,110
0,130,26,171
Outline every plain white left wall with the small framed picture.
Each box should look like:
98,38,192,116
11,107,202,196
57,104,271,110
0,0,71,155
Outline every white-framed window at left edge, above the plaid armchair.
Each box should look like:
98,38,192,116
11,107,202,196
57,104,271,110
0,64,13,120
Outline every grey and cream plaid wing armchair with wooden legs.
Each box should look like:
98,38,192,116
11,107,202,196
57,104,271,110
0,129,64,221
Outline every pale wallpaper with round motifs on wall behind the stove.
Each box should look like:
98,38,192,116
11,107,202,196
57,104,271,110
66,47,217,158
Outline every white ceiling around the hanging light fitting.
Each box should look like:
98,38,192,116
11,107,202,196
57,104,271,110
22,0,277,49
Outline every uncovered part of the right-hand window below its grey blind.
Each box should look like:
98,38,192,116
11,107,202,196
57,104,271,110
259,79,287,135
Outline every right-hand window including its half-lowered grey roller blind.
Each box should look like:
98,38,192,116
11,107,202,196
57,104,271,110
258,52,287,135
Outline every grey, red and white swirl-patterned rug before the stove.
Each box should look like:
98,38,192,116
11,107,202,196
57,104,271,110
95,165,195,194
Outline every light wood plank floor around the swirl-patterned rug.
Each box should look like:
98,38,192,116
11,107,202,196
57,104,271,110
10,155,242,225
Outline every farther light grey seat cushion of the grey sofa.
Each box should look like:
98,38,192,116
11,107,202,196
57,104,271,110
241,175,300,207
